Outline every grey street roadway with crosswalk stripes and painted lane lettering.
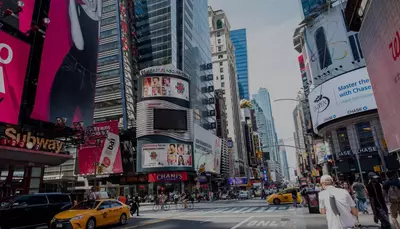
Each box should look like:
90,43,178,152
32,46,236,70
110,200,379,229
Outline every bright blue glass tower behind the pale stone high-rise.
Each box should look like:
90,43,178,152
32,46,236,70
231,29,250,100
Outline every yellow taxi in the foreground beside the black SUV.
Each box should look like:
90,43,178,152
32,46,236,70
50,199,131,229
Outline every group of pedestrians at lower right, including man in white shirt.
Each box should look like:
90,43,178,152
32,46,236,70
316,172,400,229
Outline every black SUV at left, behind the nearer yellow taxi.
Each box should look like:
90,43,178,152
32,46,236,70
0,193,73,229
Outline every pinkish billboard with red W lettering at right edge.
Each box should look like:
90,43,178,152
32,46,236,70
360,1,400,152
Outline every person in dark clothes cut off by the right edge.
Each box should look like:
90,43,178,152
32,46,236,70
383,172,400,229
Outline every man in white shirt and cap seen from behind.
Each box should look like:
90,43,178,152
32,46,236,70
319,175,358,229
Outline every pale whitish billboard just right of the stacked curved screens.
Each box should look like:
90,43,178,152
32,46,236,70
193,124,221,174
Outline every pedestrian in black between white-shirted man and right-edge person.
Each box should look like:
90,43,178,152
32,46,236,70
367,172,392,229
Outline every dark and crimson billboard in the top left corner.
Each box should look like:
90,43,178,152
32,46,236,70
0,0,35,33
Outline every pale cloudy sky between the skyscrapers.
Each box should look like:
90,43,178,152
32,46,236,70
208,0,302,180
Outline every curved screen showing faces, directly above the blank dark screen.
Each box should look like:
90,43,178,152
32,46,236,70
143,76,189,101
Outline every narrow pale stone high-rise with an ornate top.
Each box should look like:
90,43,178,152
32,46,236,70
208,7,248,176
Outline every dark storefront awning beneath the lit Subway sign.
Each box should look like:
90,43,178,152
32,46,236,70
0,146,72,166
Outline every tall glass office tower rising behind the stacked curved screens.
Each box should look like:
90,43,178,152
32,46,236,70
134,0,216,132
